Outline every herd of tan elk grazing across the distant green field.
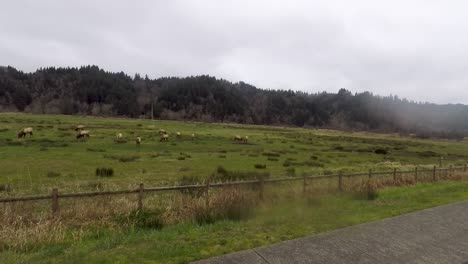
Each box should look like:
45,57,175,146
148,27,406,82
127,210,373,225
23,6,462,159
17,125,249,145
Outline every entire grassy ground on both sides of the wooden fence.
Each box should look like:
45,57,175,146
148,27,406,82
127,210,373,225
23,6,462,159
0,113,468,263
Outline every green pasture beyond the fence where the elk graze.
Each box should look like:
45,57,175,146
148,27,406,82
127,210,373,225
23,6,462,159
0,113,468,196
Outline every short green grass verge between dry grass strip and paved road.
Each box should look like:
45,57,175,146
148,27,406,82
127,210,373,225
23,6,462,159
0,181,468,263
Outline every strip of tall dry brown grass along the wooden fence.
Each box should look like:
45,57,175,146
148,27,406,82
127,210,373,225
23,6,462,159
0,167,468,250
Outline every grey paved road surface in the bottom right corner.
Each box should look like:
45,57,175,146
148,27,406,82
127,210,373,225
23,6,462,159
195,201,468,264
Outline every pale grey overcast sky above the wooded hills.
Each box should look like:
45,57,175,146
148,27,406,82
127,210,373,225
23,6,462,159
0,0,468,103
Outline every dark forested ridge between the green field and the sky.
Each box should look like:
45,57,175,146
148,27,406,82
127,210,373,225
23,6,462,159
0,66,468,139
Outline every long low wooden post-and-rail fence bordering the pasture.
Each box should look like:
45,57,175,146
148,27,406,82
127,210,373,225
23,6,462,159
0,164,467,216
